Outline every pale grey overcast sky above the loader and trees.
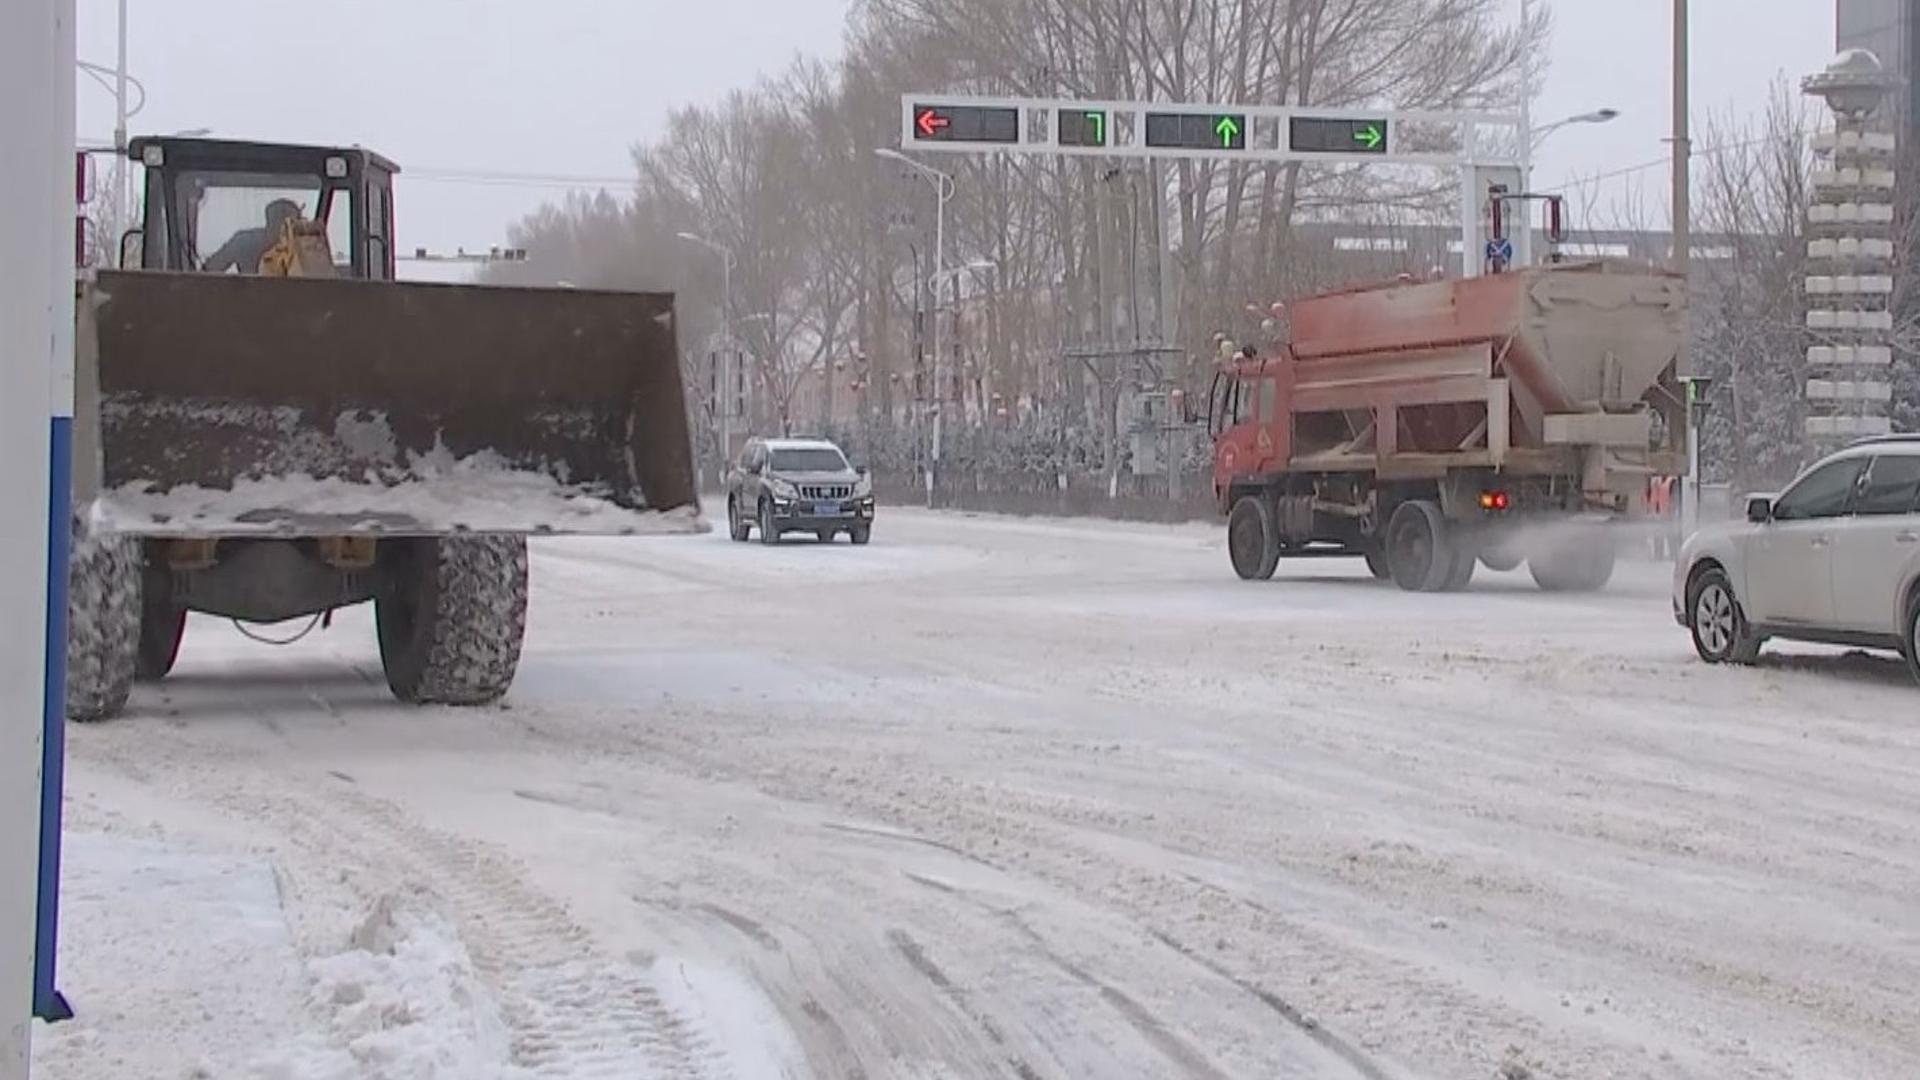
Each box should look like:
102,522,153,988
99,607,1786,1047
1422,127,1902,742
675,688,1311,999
79,0,1834,250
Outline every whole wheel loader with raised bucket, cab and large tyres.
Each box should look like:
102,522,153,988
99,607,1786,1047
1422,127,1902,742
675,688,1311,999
67,138,705,721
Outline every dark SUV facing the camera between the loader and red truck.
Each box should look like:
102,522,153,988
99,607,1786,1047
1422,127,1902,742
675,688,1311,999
726,438,874,544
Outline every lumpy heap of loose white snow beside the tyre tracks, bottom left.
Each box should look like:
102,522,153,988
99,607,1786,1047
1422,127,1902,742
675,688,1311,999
253,896,528,1080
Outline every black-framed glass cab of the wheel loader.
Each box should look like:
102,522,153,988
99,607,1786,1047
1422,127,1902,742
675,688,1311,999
119,138,399,281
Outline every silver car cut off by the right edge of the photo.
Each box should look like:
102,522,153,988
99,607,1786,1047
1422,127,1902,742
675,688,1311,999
1672,434,1920,678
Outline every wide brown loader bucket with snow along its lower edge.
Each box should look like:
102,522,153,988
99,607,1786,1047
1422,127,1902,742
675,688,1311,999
75,271,705,536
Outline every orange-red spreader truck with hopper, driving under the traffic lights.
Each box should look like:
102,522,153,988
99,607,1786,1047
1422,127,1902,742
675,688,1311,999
1208,261,1688,592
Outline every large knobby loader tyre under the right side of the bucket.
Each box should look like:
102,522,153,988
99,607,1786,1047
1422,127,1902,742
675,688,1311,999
374,536,528,705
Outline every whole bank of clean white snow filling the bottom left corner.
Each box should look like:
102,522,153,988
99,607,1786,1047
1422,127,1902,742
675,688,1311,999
33,832,526,1080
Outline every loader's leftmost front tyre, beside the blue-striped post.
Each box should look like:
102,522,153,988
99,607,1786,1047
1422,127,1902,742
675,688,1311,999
67,523,142,723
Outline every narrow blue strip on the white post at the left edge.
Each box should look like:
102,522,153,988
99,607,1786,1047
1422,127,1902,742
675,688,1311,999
33,417,73,1022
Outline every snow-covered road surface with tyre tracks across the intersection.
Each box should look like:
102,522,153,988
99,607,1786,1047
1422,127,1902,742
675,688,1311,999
35,511,1920,1080
